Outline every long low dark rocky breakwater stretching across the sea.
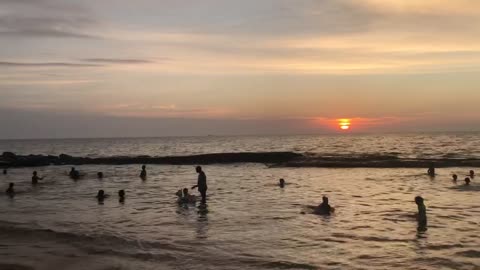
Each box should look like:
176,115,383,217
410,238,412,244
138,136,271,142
0,152,480,168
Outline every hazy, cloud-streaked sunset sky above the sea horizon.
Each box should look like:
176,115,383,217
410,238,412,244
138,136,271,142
0,0,480,139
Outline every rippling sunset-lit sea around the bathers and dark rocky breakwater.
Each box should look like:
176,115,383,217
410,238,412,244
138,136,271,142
0,133,480,270
